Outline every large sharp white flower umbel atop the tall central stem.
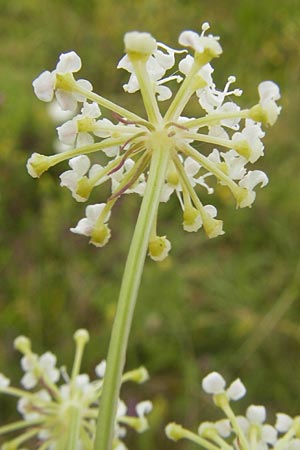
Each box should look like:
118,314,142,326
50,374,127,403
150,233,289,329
27,23,280,260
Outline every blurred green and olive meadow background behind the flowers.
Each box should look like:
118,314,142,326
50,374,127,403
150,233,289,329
0,0,300,450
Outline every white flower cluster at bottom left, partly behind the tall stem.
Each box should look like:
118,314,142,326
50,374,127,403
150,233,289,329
0,329,152,450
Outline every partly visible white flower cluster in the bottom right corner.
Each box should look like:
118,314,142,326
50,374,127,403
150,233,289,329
166,372,300,450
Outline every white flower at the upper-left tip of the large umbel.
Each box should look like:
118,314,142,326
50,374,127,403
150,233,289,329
32,51,92,111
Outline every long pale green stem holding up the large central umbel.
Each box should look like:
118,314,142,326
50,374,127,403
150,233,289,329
94,132,170,450
